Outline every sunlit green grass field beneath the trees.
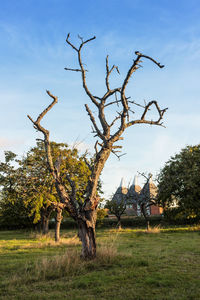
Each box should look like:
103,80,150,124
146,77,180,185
0,228,200,300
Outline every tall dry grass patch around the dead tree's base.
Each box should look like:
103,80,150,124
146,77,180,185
9,243,122,286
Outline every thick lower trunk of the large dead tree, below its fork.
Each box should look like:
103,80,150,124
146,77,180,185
78,219,96,259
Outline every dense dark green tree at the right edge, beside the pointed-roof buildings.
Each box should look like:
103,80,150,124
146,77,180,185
157,145,200,217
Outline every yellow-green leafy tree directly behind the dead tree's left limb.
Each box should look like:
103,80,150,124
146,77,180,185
19,141,90,241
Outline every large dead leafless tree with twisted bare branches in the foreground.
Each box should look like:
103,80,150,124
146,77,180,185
28,34,167,259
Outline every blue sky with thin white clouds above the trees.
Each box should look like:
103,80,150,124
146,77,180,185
0,0,200,195
